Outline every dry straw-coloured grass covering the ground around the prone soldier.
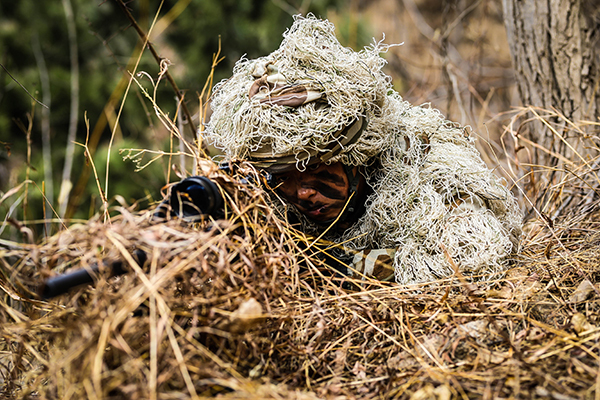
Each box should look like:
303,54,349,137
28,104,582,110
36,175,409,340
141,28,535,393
0,107,600,399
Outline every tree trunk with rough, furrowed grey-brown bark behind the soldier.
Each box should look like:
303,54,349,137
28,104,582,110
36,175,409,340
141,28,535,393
502,0,600,165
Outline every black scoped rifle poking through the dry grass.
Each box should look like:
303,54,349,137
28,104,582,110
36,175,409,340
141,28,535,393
39,176,224,299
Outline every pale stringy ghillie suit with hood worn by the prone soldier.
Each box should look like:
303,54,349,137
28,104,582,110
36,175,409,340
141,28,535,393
205,16,522,284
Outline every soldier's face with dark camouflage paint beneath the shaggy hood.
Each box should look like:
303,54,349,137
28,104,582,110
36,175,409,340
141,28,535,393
273,163,350,222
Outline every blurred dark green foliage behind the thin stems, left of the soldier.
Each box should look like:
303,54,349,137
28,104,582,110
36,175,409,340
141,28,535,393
0,0,346,241
